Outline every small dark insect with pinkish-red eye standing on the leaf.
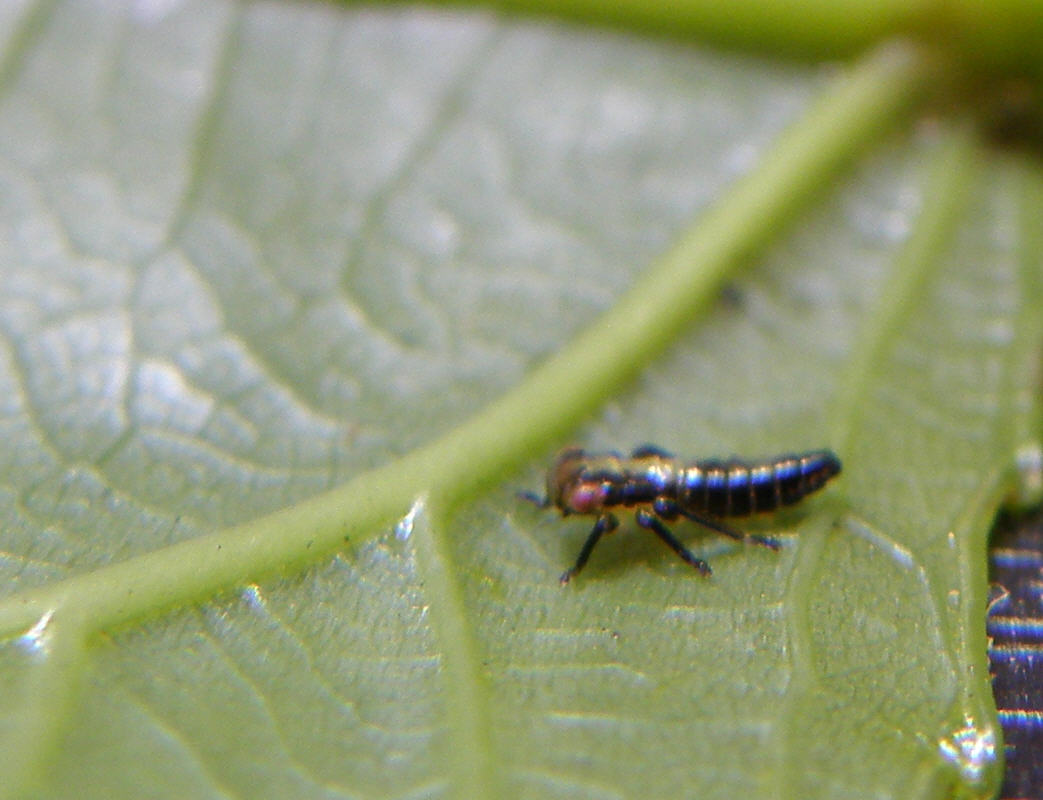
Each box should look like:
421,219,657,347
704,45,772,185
523,444,841,585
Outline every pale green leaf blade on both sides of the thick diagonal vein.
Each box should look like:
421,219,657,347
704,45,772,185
0,2,1041,798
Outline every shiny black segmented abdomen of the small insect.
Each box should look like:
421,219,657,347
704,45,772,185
677,450,841,516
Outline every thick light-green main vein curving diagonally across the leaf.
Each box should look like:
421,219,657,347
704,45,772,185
0,43,937,634
